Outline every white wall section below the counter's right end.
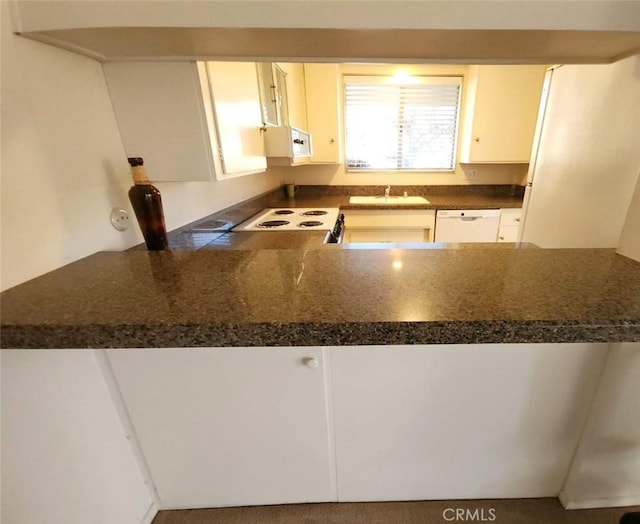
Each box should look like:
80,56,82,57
560,342,640,509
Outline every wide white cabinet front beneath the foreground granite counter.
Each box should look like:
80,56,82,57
108,343,620,509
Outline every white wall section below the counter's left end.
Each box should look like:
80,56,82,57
0,350,156,524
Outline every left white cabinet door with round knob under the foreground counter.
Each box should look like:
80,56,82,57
108,348,335,509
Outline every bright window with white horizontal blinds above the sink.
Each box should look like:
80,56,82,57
344,76,462,171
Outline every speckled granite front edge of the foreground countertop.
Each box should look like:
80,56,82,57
0,320,640,349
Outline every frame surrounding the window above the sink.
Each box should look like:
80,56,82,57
342,73,464,175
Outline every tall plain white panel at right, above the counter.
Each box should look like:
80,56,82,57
522,55,640,248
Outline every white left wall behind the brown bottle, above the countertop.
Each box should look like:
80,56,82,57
0,2,280,290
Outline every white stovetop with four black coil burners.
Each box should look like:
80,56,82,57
232,208,339,231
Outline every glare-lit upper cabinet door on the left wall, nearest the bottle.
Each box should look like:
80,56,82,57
206,62,267,178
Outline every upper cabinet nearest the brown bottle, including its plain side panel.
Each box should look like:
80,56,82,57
103,62,266,182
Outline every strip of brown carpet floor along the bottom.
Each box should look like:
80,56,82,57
152,498,640,524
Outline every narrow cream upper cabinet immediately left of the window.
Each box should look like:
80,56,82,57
304,64,342,164
